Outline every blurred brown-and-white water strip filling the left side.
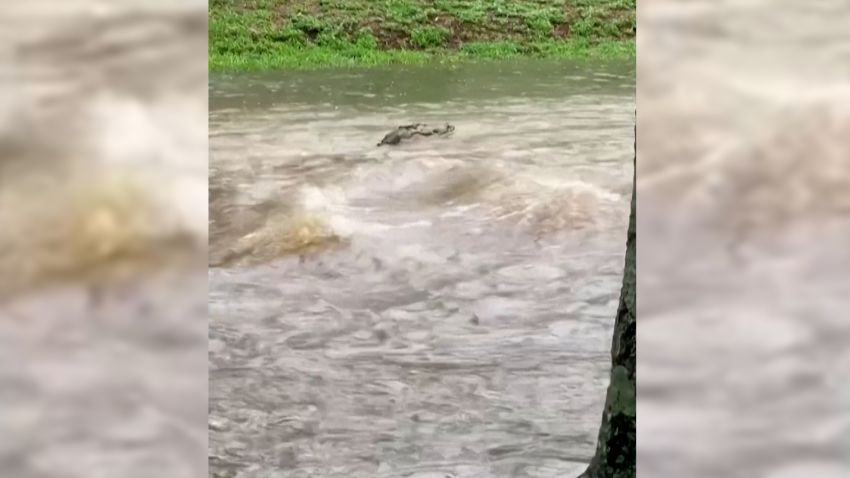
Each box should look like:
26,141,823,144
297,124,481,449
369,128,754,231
0,0,208,478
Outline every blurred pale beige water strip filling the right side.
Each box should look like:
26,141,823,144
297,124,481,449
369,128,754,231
637,0,850,478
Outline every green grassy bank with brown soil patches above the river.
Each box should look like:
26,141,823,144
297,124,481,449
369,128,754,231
209,0,636,70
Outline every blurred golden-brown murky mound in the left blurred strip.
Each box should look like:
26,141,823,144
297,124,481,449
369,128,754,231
0,167,198,299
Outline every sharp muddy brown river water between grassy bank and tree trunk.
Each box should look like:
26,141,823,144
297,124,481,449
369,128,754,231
209,62,635,478
